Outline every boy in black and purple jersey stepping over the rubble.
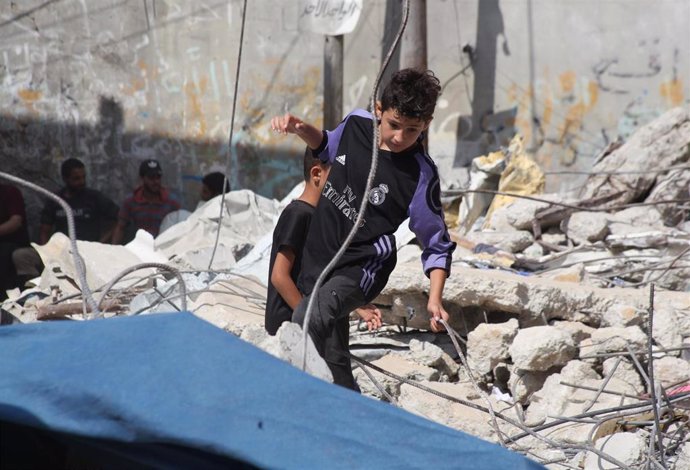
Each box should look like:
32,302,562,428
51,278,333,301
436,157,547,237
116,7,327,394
271,69,455,389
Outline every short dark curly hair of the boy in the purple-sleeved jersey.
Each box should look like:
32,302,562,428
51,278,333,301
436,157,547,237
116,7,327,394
381,69,441,122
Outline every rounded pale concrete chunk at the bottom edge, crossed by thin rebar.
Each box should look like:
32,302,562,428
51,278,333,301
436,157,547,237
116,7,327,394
585,432,648,470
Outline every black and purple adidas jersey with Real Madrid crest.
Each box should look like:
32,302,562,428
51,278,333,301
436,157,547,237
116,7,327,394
298,109,455,301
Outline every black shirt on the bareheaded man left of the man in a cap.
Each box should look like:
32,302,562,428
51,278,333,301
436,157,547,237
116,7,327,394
41,188,119,241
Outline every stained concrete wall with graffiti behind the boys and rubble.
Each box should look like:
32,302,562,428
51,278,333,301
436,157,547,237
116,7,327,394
0,0,690,235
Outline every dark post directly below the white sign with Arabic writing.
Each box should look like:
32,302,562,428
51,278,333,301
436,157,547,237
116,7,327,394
323,34,344,129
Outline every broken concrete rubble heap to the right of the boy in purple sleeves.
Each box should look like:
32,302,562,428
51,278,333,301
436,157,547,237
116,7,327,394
354,109,690,468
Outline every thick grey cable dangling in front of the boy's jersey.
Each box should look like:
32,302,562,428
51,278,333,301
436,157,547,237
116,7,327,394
302,0,410,370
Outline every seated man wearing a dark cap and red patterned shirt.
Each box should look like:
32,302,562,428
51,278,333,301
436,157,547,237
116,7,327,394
113,160,180,244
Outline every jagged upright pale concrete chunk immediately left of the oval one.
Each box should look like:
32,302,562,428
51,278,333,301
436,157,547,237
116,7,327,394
467,318,518,375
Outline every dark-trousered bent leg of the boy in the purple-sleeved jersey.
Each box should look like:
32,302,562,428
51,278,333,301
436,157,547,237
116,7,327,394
292,275,365,390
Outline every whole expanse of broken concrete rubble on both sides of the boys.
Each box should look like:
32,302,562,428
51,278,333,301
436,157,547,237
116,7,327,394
2,109,690,469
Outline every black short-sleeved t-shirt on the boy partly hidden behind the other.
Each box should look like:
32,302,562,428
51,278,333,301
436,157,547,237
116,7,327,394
265,200,314,335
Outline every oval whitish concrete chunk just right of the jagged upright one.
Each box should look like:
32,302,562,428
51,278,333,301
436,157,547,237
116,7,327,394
508,326,577,371
